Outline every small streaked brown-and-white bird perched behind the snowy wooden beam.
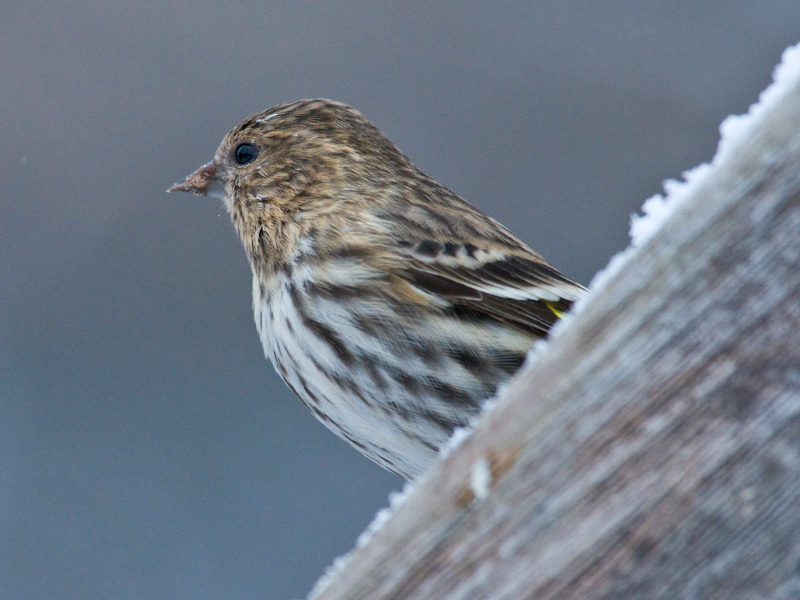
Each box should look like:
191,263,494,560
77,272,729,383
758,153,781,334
167,99,586,480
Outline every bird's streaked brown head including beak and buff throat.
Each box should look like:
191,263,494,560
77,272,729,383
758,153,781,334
167,99,414,258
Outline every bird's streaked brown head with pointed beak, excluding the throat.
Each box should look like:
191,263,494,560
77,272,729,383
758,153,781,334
167,99,410,214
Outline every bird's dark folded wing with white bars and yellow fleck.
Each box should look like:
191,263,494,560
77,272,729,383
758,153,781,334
402,241,586,336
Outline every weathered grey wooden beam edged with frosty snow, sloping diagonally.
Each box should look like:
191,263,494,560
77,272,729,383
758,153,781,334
313,47,800,600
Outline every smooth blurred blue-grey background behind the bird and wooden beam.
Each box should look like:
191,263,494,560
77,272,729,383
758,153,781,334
0,0,800,600
